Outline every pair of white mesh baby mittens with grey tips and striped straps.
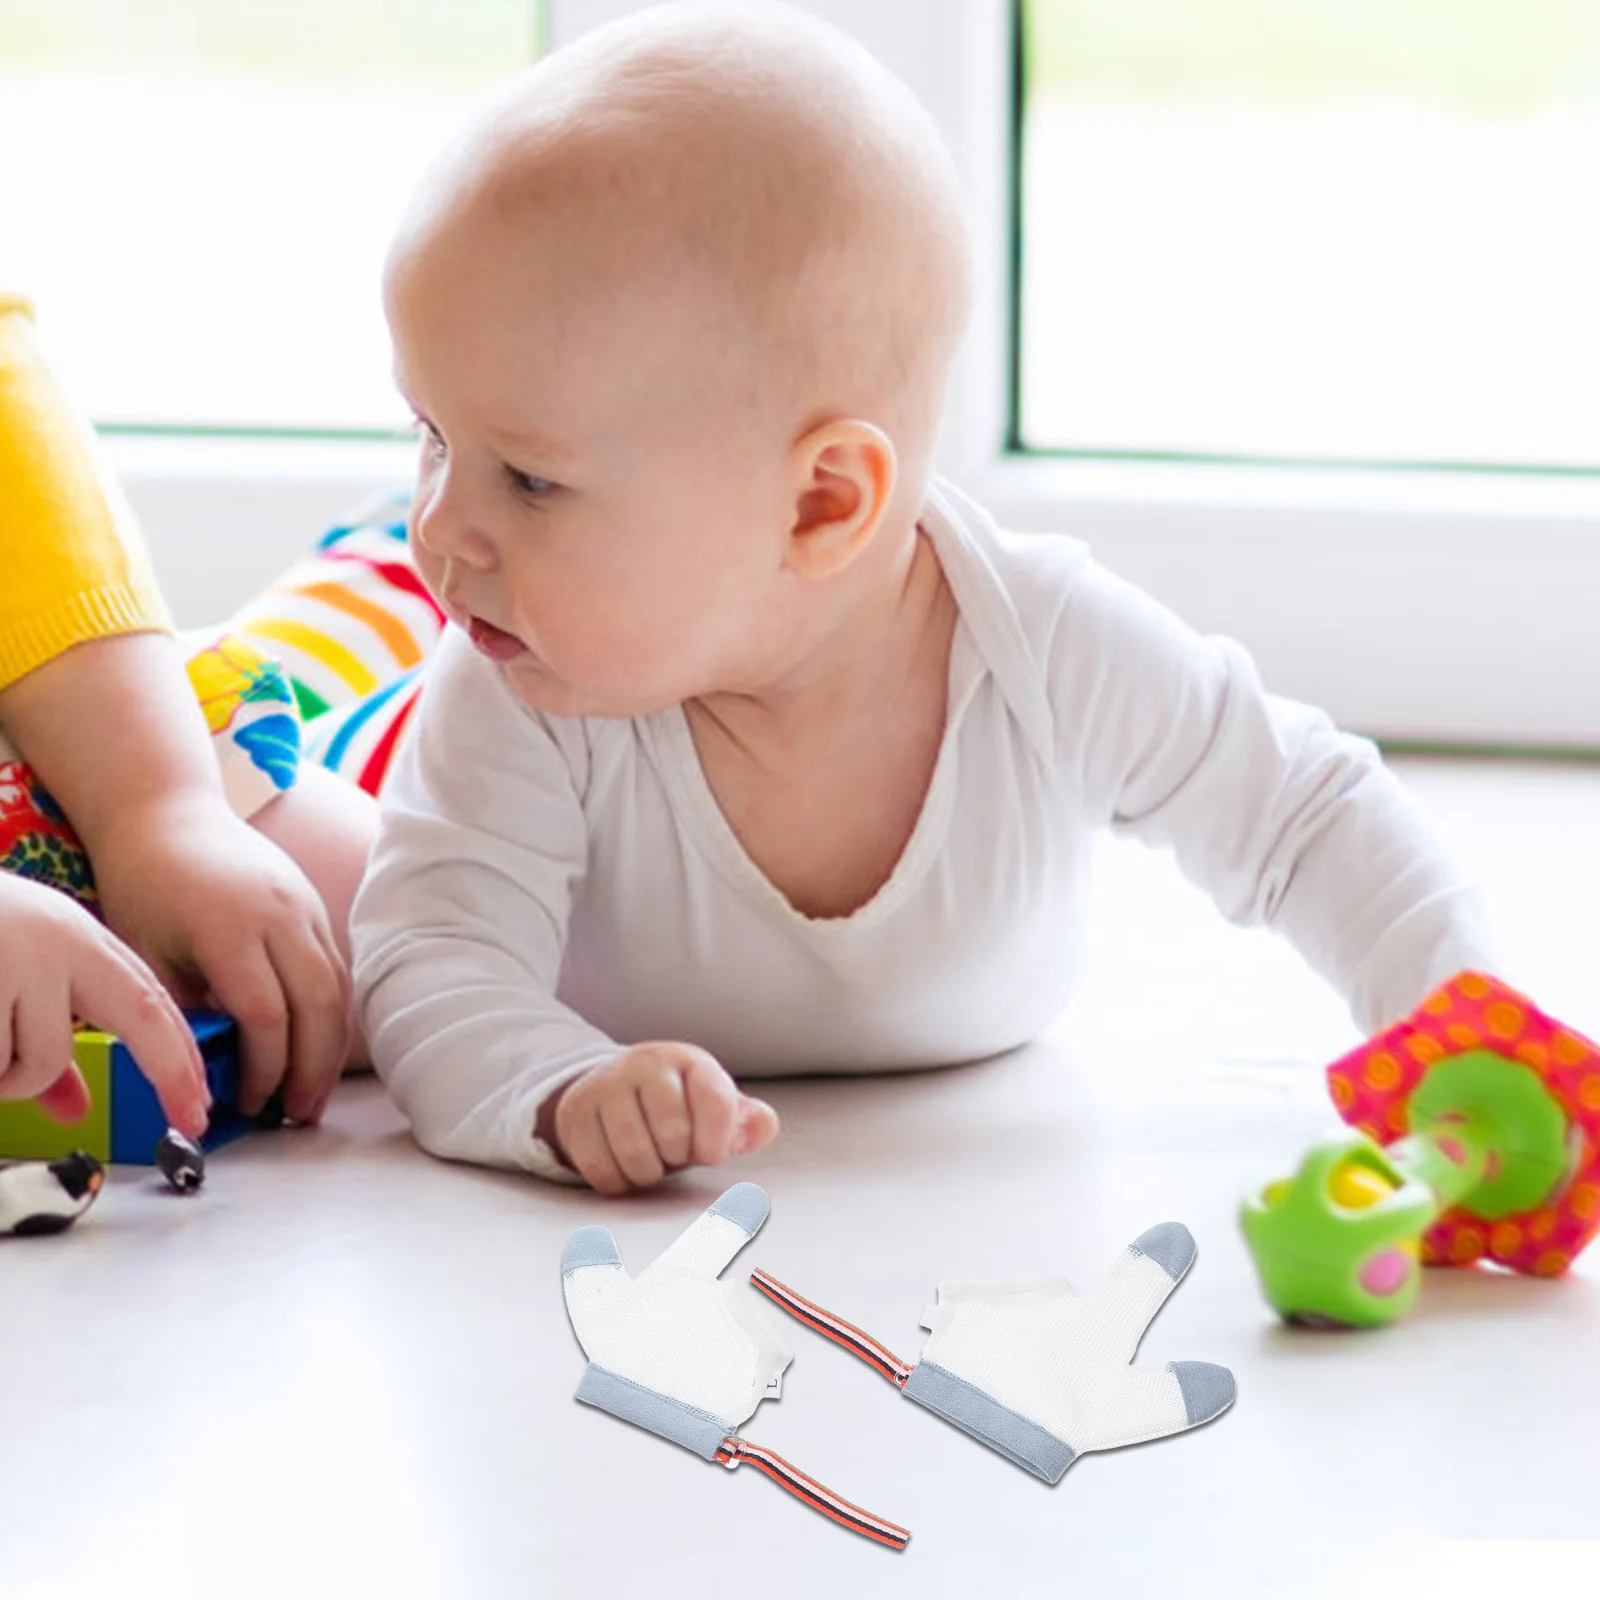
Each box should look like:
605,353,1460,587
562,1184,1235,1550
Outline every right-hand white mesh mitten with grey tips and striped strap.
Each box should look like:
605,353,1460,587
750,1222,1235,1483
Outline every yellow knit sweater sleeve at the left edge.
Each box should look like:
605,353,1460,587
0,291,171,690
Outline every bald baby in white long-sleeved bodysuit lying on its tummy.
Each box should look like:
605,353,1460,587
354,6,1494,1194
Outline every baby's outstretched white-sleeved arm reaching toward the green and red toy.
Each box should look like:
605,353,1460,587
1053,566,1499,1032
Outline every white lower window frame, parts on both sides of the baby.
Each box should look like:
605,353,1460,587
106,435,1600,749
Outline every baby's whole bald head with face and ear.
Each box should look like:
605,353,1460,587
384,5,968,715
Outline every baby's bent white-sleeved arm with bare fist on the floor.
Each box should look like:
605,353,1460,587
352,630,776,1194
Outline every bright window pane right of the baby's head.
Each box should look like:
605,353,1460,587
1013,0,1600,470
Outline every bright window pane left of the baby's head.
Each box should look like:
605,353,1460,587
0,0,539,432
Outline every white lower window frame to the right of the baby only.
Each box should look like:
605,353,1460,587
971,458,1600,749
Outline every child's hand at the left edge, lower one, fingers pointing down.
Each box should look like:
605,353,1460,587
0,874,211,1139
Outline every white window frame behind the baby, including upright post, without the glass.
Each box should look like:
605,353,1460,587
109,0,1600,754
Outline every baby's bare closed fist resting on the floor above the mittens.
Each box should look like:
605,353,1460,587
539,1042,778,1195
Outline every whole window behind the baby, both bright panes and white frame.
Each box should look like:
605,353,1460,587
40,0,1600,750
